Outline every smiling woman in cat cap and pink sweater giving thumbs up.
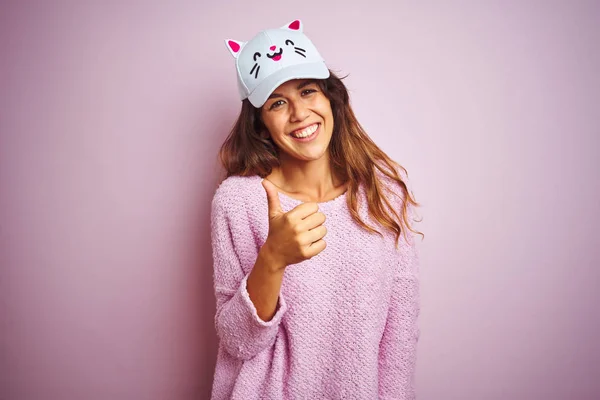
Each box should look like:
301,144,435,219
211,20,419,400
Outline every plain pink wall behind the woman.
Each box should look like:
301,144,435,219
0,0,600,400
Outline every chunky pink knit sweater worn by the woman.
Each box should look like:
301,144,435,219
211,176,419,400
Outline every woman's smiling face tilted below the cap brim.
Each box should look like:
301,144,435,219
260,79,333,162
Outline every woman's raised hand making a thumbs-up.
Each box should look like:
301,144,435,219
262,179,327,268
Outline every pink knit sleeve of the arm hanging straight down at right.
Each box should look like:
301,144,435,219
379,209,420,400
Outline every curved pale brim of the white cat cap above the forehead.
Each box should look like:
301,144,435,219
248,61,329,108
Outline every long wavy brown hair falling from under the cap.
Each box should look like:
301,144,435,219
219,71,424,246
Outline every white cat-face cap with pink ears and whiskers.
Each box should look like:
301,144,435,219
225,20,329,108
